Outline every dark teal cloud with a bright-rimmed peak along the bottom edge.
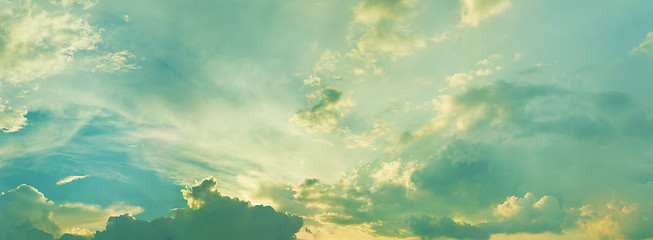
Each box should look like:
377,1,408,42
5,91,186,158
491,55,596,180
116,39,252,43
93,178,303,240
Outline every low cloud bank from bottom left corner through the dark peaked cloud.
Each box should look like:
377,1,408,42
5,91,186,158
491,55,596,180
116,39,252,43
0,178,303,240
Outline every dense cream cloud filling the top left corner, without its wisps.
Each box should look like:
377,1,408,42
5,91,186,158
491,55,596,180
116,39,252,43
0,0,101,83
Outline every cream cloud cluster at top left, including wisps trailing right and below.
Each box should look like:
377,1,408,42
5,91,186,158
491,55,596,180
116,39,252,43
0,0,140,136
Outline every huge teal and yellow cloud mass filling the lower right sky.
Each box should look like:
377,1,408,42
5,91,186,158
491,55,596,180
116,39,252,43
260,81,653,239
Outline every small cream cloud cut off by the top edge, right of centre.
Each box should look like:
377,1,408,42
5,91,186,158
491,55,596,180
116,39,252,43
460,0,511,27
